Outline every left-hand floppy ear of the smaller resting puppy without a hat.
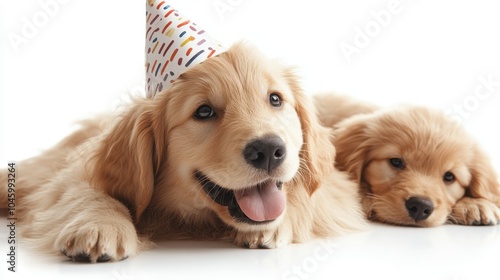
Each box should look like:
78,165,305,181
333,115,370,183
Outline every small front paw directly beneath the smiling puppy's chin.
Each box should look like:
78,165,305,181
234,226,293,249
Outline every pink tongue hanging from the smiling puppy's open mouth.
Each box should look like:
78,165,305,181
234,181,285,222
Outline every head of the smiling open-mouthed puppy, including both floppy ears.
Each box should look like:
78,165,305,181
94,43,334,230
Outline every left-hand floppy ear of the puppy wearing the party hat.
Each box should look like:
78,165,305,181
92,97,165,222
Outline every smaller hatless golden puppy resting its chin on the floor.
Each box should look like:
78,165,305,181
315,94,500,227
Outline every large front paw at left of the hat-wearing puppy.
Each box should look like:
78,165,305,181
55,217,138,263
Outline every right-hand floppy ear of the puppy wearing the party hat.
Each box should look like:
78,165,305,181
287,72,335,195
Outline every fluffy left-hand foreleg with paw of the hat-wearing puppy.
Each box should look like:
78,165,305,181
23,175,140,262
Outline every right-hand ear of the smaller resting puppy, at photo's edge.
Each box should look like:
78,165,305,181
467,147,500,207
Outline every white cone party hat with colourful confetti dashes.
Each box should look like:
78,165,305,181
146,0,225,97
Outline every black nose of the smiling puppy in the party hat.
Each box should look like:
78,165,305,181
243,136,286,173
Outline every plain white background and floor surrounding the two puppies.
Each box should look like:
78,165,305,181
0,0,500,280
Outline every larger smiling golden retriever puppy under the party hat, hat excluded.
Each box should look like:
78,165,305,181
0,43,365,262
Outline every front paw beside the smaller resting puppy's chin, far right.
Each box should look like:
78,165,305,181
451,197,500,225
